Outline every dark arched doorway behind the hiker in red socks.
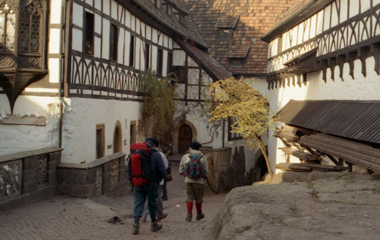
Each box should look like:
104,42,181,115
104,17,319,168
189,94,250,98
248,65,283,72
173,121,198,154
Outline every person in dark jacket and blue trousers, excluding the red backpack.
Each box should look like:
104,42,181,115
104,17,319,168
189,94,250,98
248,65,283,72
128,138,166,235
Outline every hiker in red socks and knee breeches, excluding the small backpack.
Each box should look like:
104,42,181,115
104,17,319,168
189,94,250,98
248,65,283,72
179,142,209,222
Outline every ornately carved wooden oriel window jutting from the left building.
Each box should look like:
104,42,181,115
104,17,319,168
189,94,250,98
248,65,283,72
0,0,48,112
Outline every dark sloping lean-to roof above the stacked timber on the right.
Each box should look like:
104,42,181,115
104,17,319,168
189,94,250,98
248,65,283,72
278,100,380,144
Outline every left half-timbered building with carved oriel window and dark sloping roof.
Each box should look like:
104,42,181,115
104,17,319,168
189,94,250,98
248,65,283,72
0,0,231,196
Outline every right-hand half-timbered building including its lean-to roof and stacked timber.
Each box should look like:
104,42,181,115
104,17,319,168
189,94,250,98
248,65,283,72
262,0,380,172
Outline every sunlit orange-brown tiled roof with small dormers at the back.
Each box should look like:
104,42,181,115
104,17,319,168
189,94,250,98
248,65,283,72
183,0,298,75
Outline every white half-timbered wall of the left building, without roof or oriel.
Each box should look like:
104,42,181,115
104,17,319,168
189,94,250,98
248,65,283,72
0,0,223,164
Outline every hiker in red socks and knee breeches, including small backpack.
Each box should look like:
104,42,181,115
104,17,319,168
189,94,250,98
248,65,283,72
179,142,209,222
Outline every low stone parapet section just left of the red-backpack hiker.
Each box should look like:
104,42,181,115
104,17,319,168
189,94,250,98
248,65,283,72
57,152,129,198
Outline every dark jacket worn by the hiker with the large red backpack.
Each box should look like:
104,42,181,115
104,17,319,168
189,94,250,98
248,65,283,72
128,148,166,190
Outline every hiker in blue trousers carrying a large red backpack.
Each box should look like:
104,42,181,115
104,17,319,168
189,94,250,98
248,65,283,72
127,138,166,234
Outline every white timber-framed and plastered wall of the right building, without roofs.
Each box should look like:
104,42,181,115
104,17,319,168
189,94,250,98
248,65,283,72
268,0,380,172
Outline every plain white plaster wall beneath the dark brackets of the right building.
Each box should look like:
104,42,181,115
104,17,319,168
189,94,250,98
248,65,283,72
267,57,380,172
